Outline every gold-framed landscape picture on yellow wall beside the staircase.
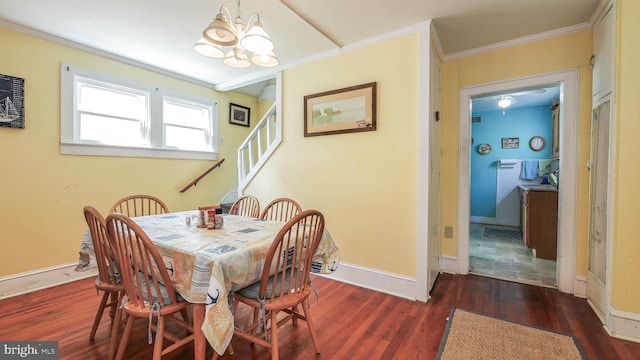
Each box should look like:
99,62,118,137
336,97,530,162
304,82,376,137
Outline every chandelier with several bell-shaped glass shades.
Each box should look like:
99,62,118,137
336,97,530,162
193,0,278,68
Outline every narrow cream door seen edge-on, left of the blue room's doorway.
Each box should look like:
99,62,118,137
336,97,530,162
427,53,441,292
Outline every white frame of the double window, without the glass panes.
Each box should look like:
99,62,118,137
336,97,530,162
60,63,219,160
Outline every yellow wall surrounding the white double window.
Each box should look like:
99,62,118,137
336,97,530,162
0,28,257,276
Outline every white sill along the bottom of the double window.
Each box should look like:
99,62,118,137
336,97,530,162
60,143,218,160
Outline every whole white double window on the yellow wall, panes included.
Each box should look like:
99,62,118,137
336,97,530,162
61,64,218,159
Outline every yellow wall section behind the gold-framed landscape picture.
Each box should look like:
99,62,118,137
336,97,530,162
246,34,418,276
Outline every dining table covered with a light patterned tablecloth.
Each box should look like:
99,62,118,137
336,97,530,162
76,210,340,359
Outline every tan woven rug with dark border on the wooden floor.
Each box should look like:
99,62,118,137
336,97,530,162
436,307,587,360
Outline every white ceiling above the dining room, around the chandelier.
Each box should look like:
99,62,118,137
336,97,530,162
0,0,600,90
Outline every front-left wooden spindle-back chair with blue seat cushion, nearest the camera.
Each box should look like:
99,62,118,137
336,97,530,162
106,214,194,360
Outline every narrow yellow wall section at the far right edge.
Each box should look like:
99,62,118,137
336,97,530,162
611,0,640,313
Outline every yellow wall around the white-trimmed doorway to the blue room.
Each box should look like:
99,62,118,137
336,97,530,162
441,30,592,276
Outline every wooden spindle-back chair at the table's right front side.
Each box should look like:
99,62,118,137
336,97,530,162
234,210,324,359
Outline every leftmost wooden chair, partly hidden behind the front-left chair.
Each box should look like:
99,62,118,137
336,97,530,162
83,205,124,358
